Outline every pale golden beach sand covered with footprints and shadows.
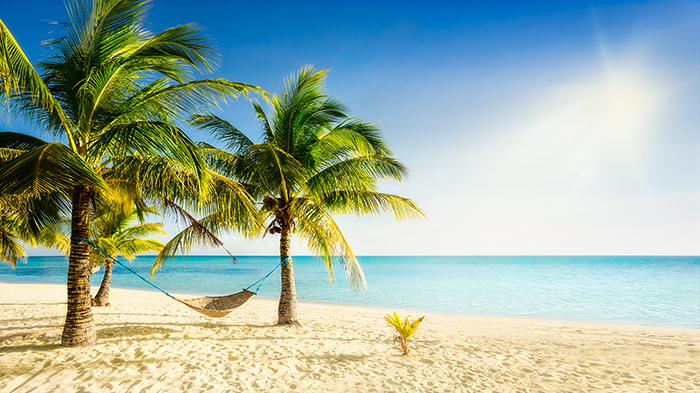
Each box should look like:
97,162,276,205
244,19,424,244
0,283,700,393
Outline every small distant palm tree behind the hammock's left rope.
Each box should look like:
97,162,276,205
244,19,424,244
90,207,165,307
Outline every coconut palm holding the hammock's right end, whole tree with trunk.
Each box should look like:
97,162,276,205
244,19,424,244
190,66,423,324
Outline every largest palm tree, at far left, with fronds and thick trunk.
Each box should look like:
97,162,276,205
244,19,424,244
0,0,251,346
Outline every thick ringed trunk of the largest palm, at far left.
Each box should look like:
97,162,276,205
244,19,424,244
61,186,97,347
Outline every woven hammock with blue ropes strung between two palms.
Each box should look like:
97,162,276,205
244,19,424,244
79,238,289,318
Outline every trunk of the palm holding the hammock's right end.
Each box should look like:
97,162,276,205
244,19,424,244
277,225,299,325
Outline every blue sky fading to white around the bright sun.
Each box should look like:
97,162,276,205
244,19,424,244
0,0,700,255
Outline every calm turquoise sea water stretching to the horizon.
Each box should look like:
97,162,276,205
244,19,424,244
0,256,700,329
